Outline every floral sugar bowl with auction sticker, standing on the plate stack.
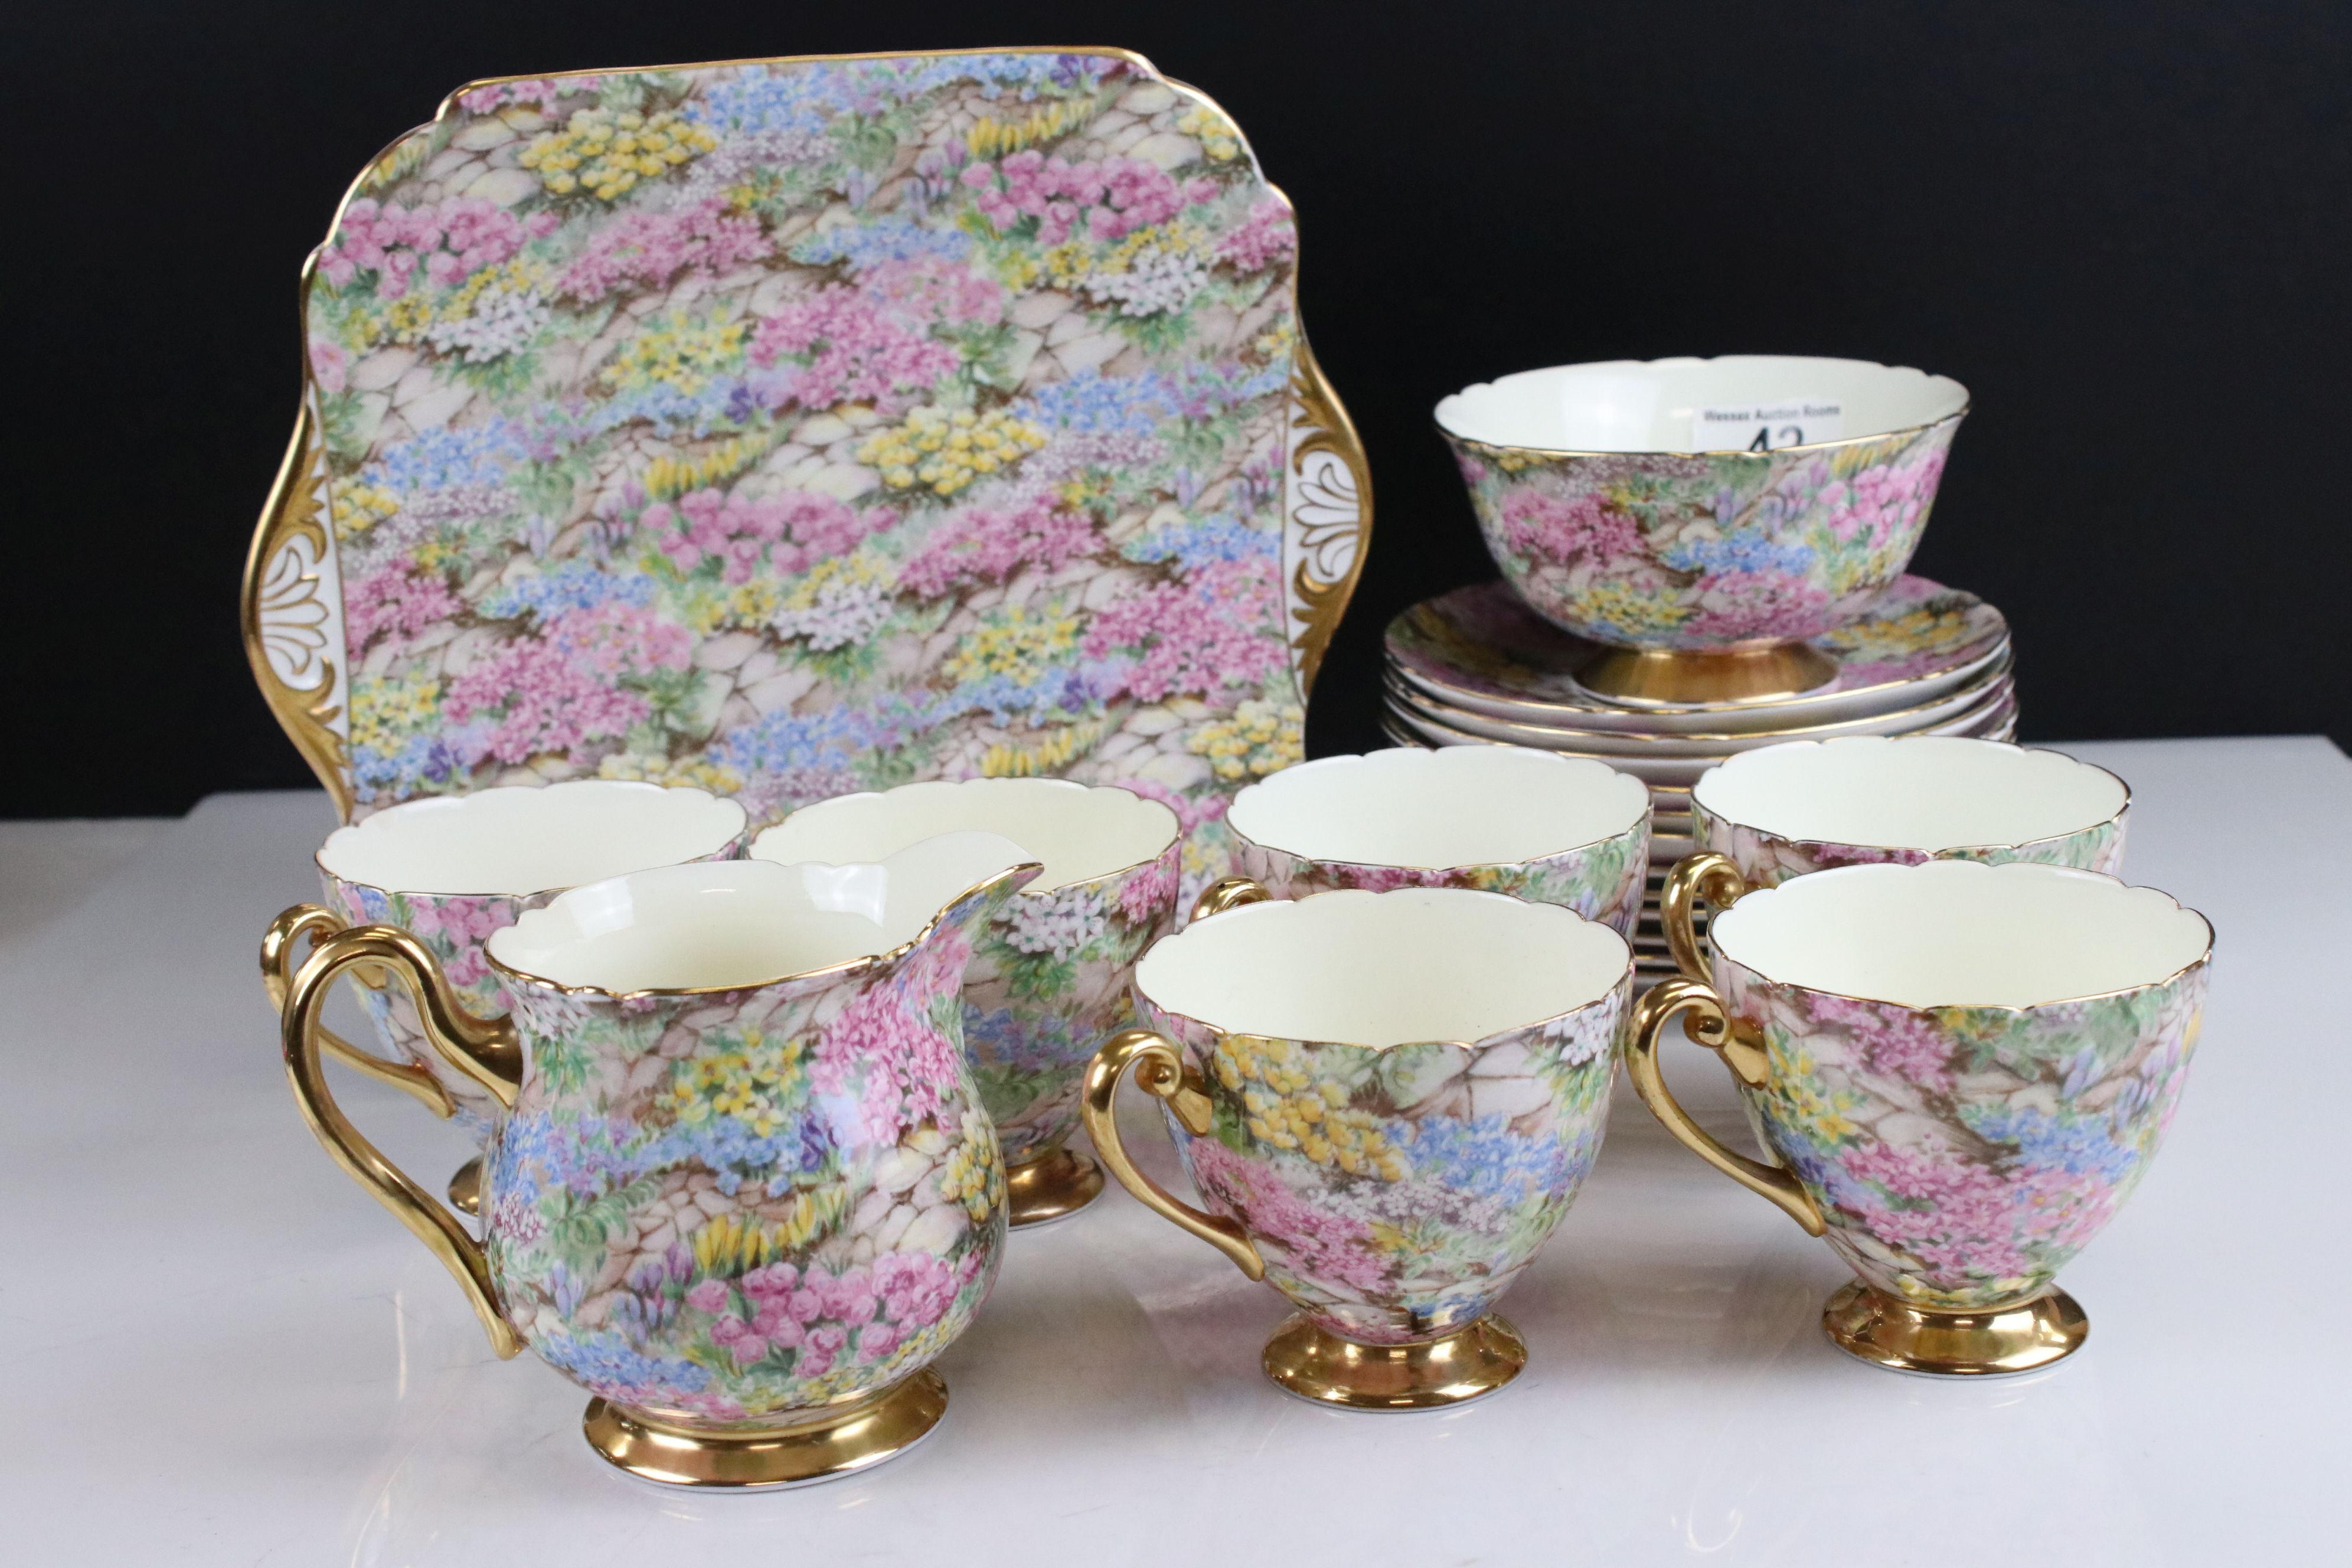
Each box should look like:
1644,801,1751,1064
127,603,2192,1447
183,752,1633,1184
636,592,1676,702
1437,355,1969,703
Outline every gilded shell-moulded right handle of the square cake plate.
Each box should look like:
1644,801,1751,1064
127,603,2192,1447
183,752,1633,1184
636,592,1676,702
1282,336,1371,696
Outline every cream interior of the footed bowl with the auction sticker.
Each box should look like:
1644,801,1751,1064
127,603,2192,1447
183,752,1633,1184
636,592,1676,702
1437,355,1969,452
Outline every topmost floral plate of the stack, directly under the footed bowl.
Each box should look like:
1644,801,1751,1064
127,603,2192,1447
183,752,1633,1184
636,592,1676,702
1388,576,2008,736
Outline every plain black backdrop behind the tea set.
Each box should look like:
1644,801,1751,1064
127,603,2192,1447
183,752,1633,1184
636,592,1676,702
0,0,2352,816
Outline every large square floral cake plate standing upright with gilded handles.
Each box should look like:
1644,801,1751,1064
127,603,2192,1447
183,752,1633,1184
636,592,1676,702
242,50,1371,907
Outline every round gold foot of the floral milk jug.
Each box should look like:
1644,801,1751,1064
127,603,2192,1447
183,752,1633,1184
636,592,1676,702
581,1371,948,1491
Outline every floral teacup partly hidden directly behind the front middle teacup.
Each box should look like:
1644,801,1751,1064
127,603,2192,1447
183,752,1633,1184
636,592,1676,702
1226,745,1649,938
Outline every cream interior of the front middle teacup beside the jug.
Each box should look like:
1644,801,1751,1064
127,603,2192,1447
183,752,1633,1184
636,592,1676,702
1136,888,1632,1048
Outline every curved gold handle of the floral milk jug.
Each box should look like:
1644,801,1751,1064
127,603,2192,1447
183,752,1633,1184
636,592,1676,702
280,917,522,1359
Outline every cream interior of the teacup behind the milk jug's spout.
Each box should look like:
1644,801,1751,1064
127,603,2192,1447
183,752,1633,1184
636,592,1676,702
750,778,1181,893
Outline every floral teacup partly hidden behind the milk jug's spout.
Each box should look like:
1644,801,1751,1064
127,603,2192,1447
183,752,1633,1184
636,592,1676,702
750,778,1183,1227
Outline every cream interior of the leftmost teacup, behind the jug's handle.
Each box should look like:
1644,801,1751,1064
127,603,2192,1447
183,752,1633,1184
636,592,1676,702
318,778,746,898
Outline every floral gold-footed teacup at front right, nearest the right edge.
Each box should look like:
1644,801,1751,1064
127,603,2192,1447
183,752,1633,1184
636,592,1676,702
1625,853,2213,1375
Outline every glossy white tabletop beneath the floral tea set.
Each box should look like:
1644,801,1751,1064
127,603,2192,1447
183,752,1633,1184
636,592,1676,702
0,738,2352,1568
